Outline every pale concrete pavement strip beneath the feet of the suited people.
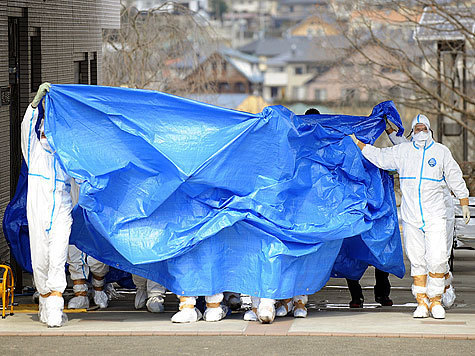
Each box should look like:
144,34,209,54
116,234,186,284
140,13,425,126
0,308,475,340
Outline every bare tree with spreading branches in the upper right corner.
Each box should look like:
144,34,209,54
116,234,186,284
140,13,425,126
333,0,475,160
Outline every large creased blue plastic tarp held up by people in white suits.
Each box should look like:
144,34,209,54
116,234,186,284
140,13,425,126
1,85,404,298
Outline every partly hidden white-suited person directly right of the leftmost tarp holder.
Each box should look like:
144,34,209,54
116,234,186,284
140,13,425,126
67,179,109,309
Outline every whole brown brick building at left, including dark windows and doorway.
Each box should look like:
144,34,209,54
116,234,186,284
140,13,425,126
0,0,120,263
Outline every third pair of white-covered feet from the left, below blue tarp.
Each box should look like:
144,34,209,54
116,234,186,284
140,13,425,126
132,274,166,313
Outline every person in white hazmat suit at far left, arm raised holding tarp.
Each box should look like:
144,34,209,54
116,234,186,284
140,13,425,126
21,83,72,327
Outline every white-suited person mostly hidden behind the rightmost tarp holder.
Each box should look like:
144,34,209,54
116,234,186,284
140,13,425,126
386,120,456,308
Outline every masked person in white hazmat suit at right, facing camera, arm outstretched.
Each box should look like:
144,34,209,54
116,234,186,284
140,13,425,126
350,115,470,319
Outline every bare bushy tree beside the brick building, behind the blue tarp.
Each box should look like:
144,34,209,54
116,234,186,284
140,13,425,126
102,1,217,95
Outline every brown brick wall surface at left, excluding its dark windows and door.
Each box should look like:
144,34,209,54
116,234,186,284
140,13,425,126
0,0,120,262
